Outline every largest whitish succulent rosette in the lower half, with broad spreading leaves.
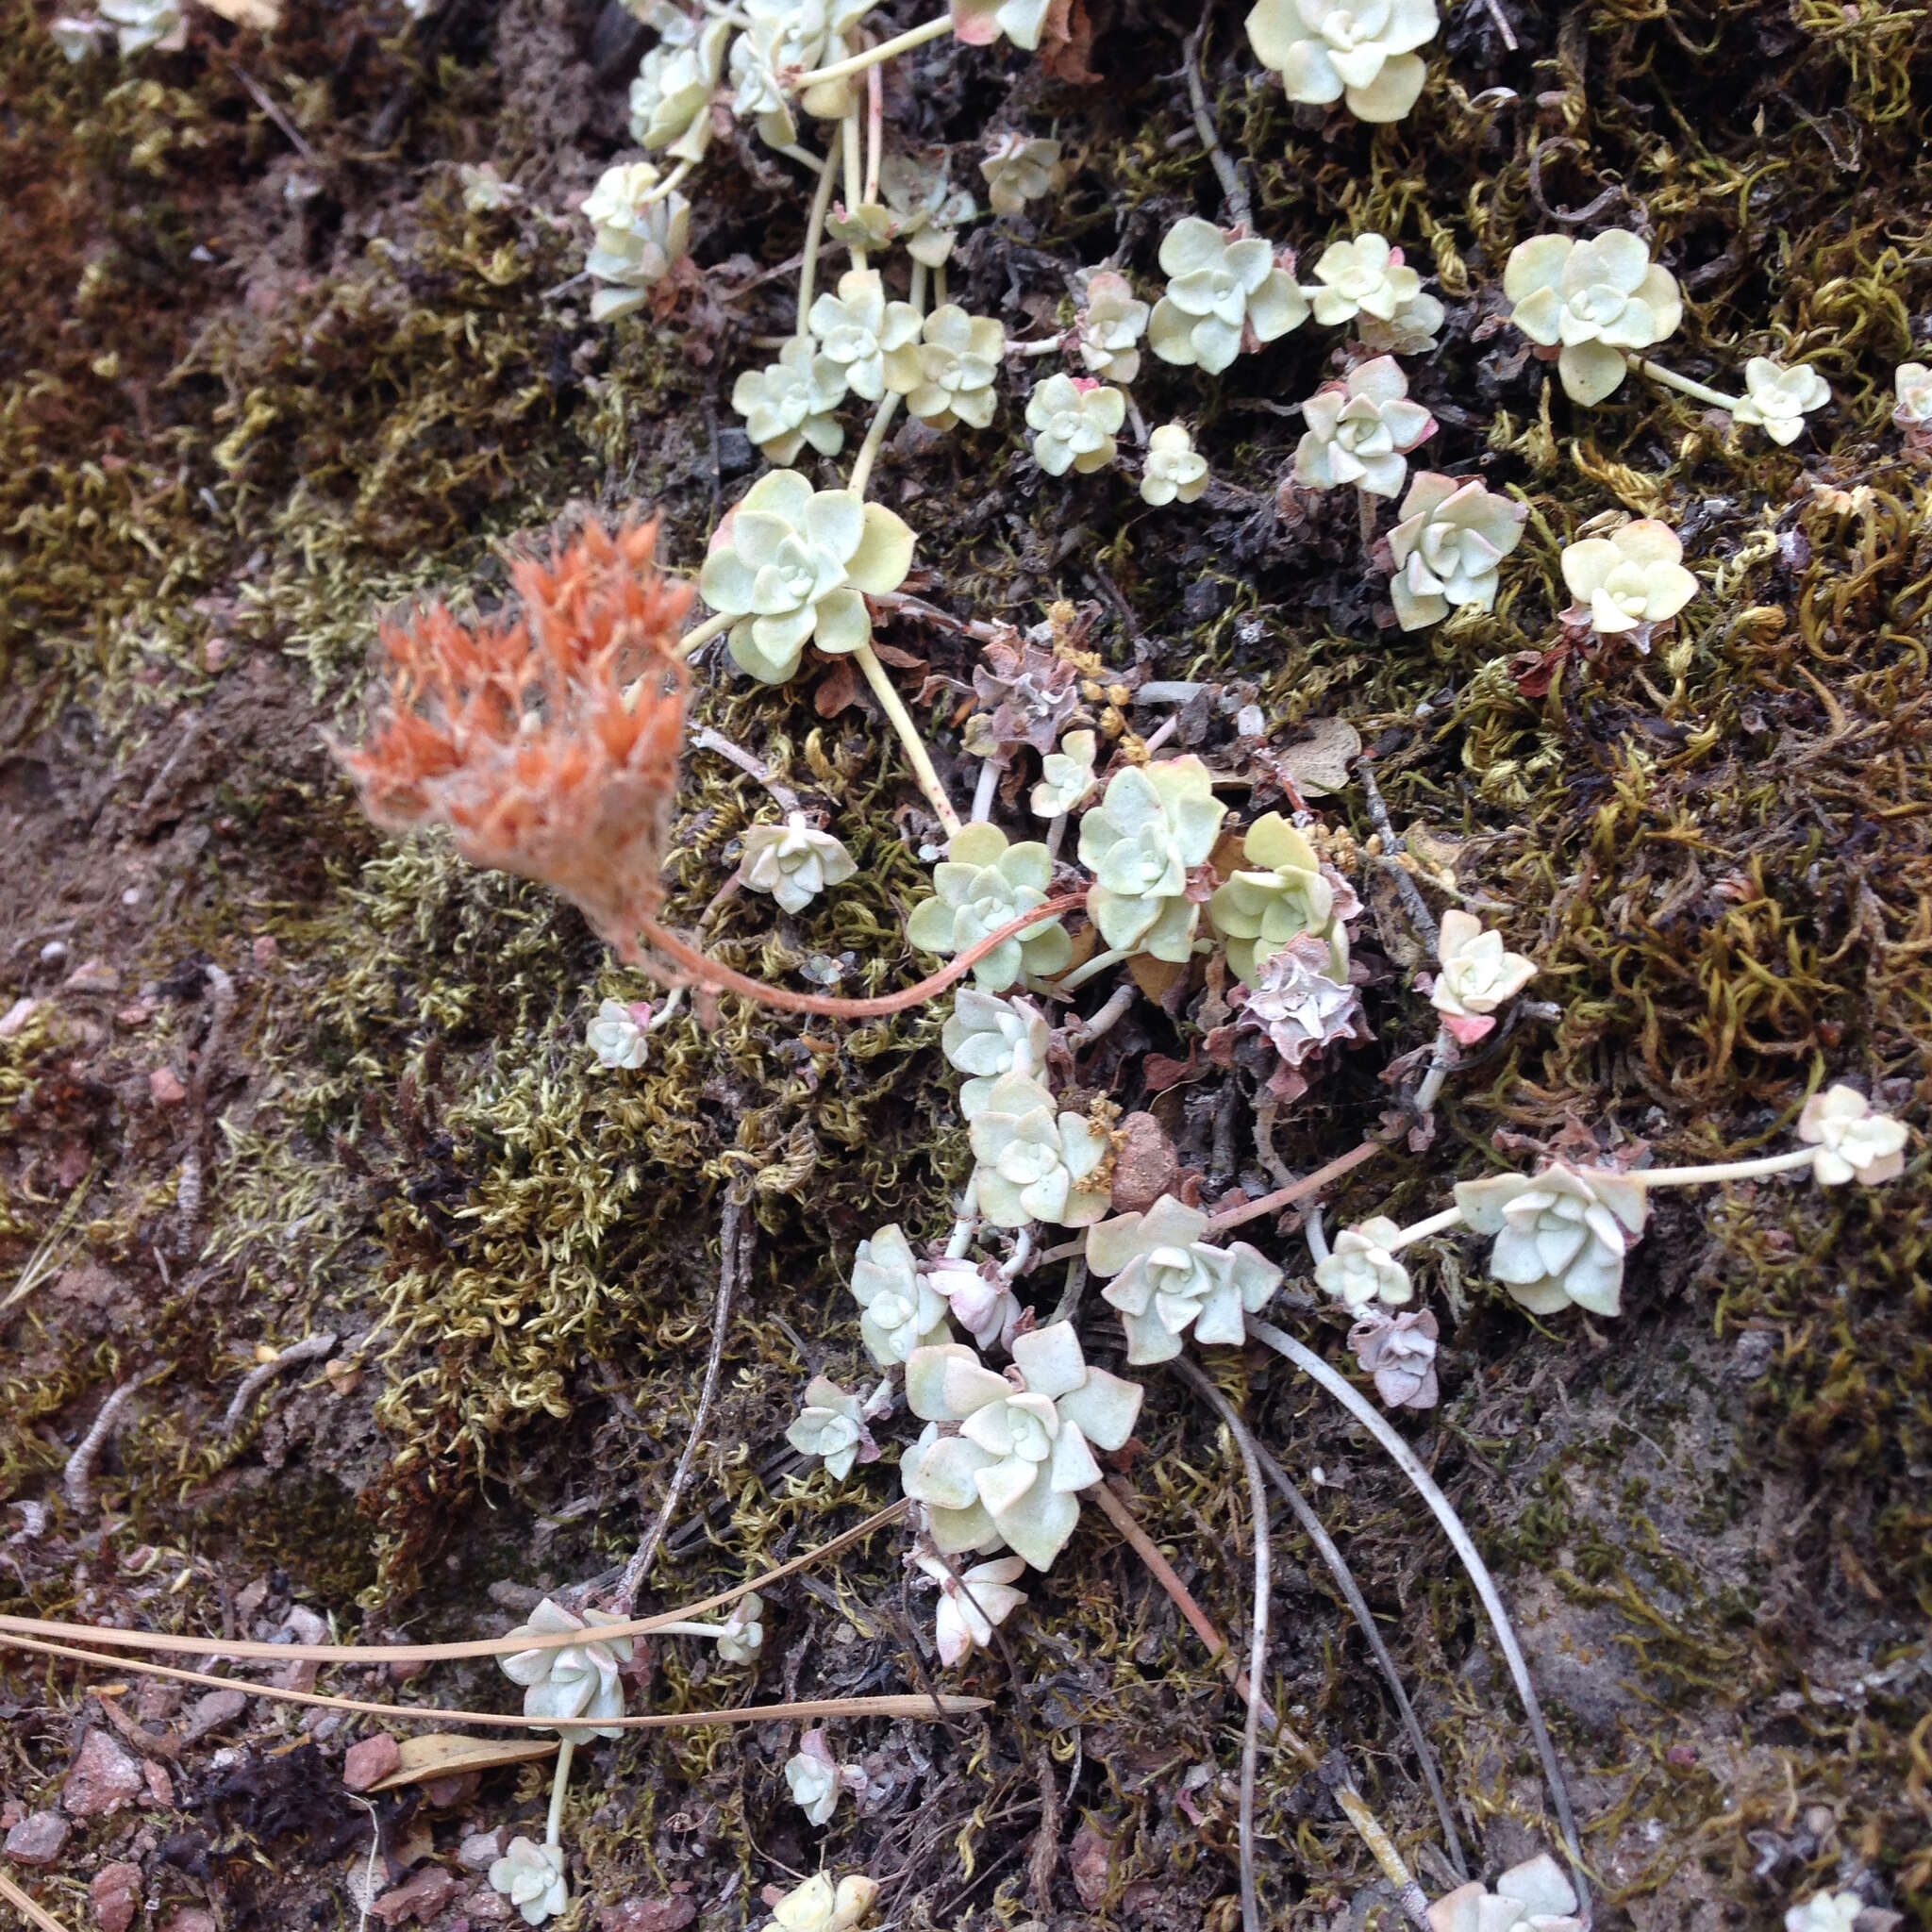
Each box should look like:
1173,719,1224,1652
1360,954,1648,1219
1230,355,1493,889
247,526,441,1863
900,1322,1141,1569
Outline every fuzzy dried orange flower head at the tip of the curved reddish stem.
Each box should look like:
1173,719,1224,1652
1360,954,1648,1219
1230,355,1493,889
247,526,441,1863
330,522,691,960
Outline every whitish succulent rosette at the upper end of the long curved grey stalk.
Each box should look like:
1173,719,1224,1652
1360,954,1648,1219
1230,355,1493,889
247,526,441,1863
1086,1194,1281,1368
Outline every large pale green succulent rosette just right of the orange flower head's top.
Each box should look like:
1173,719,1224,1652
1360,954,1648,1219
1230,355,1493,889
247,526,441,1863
697,470,912,684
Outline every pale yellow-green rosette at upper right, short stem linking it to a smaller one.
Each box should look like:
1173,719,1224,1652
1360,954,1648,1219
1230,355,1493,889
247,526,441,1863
1503,228,1683,404
